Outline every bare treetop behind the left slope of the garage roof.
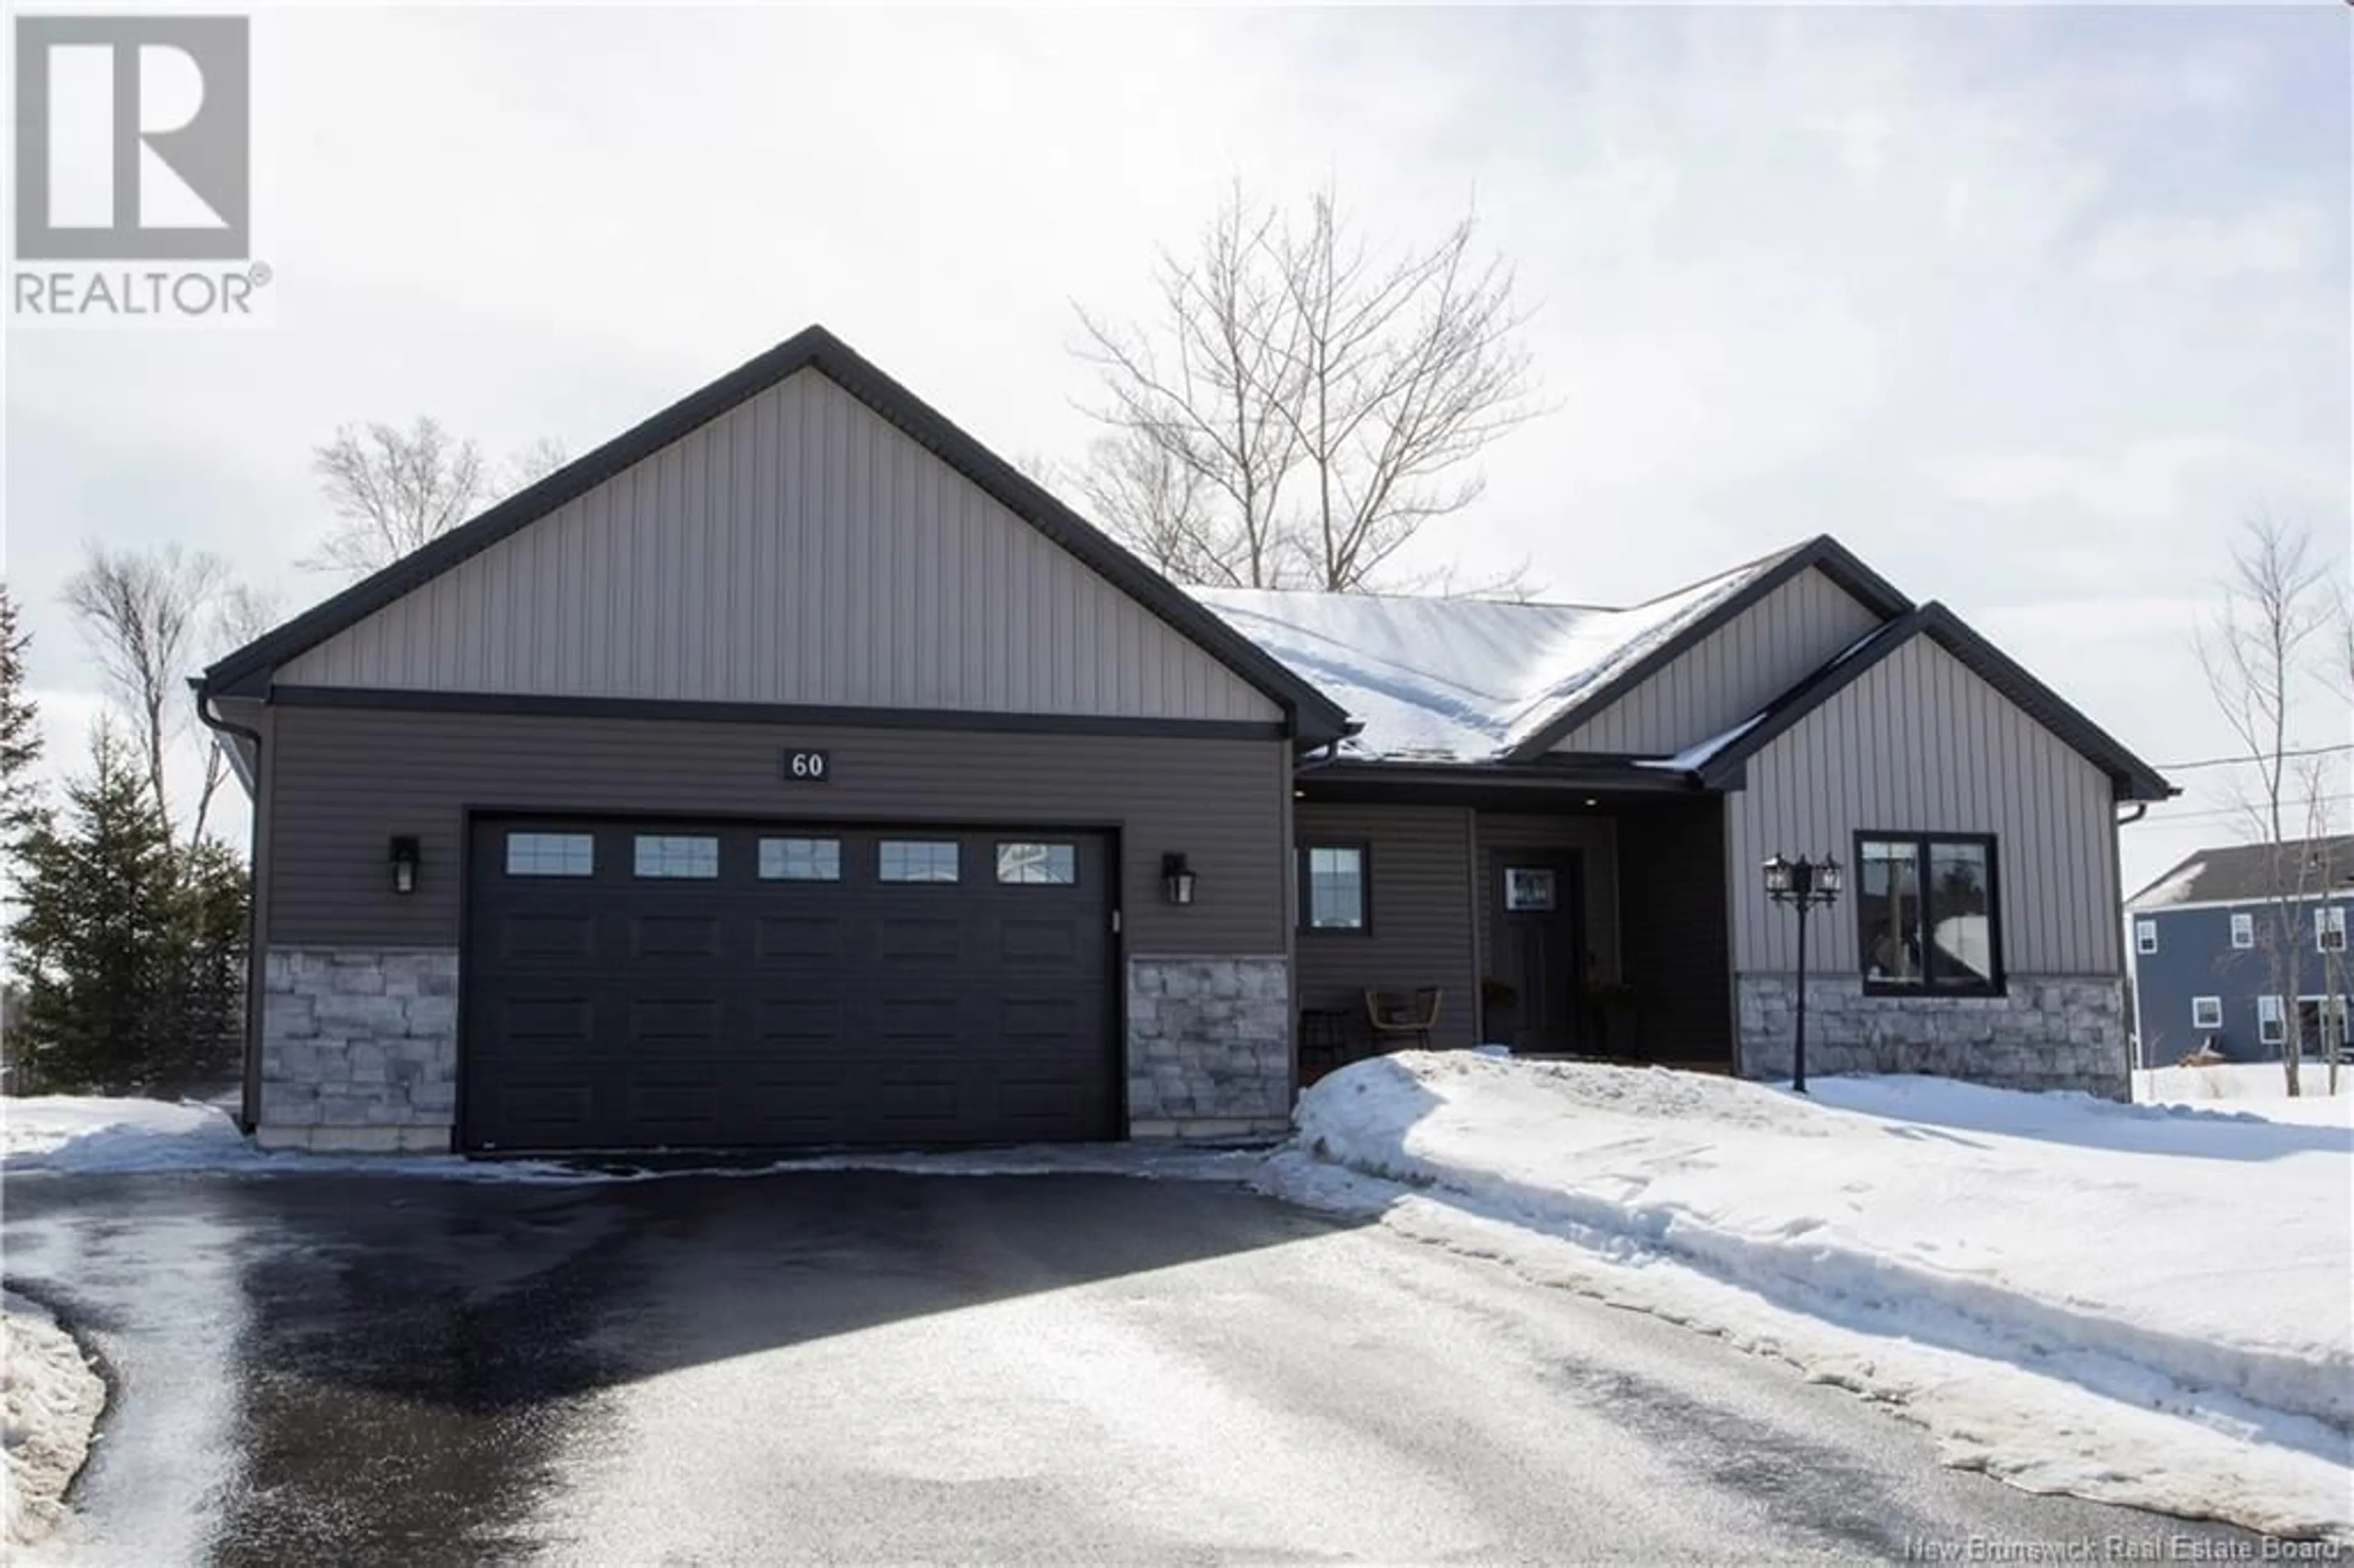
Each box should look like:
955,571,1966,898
297,417,565,577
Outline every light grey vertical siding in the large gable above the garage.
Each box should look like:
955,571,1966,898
278,370,1283,723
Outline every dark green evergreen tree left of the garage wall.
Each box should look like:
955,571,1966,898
12,723,188,1090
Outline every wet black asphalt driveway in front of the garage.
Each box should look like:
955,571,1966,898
5,1173,2260,1566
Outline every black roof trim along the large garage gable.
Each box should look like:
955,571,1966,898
205,325,1349,742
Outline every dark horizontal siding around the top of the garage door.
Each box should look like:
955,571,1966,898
264,706,1290,956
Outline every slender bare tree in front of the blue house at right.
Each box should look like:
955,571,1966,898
2199,513,2328,1095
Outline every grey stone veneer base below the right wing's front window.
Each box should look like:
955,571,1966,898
1735,975,2133,1100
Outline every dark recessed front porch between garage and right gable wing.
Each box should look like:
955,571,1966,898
1292,763,1735,1081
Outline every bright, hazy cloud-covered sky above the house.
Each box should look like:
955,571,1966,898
5,5,2354,885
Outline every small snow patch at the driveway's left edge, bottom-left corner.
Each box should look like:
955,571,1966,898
0,1293,106,1547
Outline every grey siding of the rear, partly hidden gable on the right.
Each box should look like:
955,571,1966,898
1553,572,1881,756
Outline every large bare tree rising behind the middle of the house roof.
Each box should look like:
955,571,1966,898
1078,186,1537,591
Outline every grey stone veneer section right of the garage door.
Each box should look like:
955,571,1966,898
1127,954,1292,1140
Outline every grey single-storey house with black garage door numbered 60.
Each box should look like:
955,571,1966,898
198,327,2170,1151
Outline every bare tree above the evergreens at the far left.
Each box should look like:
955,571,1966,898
66,544,228,831
